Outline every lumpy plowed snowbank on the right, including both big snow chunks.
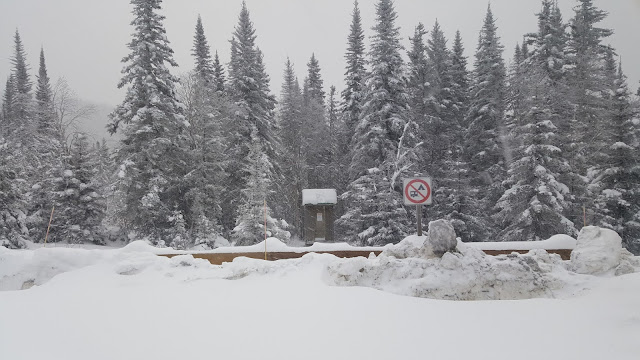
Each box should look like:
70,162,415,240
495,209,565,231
329,222,640,300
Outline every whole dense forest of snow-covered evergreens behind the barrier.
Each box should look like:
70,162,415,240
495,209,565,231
0,0,640,253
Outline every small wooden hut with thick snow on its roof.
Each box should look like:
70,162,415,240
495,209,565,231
302,189,338,245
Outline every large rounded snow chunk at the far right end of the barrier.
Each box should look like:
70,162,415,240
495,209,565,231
571,226,622,274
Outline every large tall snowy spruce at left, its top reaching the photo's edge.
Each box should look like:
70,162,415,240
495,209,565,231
108,0,186,242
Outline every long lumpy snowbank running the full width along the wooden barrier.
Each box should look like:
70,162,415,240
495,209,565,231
0,222,640,300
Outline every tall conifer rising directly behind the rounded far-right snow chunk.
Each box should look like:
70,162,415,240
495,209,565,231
566,0,615,224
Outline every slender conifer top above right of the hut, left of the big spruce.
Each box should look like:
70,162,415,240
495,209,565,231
341,0,366,152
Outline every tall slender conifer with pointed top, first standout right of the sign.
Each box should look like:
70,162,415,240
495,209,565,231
465,7,506,233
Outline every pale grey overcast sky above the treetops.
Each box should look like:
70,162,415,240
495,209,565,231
0,0,640,105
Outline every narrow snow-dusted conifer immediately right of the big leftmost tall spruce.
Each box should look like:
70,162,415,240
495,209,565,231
178,16,234,248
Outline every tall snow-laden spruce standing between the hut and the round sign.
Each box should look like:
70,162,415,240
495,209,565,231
337,0,415,245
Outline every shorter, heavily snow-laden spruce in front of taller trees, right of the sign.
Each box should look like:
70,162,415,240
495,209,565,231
496,67,576,241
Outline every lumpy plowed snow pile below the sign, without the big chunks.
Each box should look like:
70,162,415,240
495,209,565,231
328,242,579,300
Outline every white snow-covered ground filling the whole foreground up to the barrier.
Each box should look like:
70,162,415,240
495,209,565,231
0,228,640,360
